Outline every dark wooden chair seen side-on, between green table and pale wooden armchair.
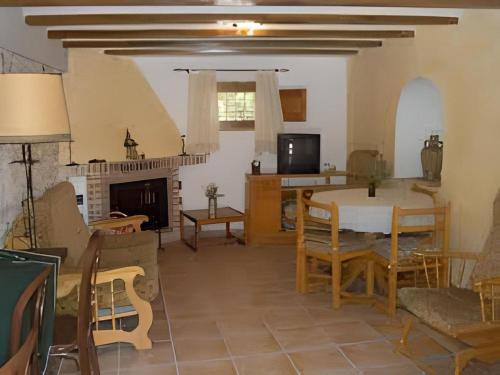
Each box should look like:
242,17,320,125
50,230,103,375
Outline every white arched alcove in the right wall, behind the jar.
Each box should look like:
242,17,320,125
394,77,443,178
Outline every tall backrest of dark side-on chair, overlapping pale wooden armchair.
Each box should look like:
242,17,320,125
76,231,104,375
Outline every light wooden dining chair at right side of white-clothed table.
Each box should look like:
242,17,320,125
373,204,450,316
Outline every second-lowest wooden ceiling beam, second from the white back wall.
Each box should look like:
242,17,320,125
63,39,382,49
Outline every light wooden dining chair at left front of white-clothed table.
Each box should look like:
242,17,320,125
297,189,374,309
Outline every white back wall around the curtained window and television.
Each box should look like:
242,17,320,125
135,56,346,214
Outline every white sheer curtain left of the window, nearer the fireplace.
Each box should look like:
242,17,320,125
186,71,219,154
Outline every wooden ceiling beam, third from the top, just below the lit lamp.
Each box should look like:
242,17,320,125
48,29,415,40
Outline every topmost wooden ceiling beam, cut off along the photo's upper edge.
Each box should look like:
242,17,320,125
0,0,500,9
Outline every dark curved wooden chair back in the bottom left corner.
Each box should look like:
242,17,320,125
0,266,52,375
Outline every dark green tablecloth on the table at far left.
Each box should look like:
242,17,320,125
0,250,59,371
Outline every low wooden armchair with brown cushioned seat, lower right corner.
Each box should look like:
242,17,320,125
398,193,500,375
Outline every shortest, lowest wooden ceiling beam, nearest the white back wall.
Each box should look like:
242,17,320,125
104,49,358,56
